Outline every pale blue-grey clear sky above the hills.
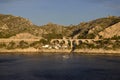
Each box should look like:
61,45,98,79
0,0,120,25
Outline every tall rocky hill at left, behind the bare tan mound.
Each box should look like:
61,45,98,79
0,14,43,38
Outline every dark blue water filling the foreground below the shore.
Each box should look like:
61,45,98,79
0,54,120,80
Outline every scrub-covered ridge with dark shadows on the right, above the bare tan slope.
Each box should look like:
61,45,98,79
70,16,120,39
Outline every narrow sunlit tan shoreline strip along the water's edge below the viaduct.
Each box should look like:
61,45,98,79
0,48,120,56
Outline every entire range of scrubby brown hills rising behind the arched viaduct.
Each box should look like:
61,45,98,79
0,14,120,40
